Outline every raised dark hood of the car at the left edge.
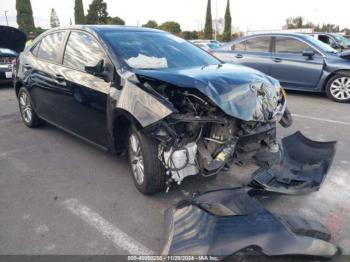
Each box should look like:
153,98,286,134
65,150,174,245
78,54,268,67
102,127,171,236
0,26,27,53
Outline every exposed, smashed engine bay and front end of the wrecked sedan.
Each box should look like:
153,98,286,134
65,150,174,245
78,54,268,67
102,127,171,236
143,79,292,185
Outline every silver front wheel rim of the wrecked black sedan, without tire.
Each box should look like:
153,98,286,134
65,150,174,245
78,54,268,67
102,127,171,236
129,134,145,185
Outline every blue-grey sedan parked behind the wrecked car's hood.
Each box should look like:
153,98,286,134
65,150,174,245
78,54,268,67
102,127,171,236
214,33,350,103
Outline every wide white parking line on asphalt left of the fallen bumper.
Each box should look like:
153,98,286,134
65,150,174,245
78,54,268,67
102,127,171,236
62,198,154,255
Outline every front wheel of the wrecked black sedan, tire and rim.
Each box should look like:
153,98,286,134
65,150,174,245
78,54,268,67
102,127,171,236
128,127,166,195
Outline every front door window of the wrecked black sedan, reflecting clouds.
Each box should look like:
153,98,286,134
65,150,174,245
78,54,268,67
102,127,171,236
63,31,105,70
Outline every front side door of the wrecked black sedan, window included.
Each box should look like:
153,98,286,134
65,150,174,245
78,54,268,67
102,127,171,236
55,30,113,149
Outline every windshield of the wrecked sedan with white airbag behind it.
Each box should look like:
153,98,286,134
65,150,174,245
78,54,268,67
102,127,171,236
103,31,220,69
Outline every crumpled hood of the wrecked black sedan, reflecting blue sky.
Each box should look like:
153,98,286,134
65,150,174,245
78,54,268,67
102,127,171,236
135,64,281,122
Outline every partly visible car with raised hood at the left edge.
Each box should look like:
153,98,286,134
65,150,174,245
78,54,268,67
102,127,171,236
0,26,26,82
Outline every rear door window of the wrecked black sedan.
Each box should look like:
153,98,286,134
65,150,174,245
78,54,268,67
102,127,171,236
37,31,65,62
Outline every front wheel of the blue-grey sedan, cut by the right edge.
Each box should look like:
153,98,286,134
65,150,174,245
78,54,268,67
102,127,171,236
326,72,350,103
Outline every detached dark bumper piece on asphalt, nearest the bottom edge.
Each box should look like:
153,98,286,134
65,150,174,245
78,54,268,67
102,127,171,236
163,188,339,258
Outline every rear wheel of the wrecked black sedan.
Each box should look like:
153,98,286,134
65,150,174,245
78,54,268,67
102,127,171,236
18,87,44,128
